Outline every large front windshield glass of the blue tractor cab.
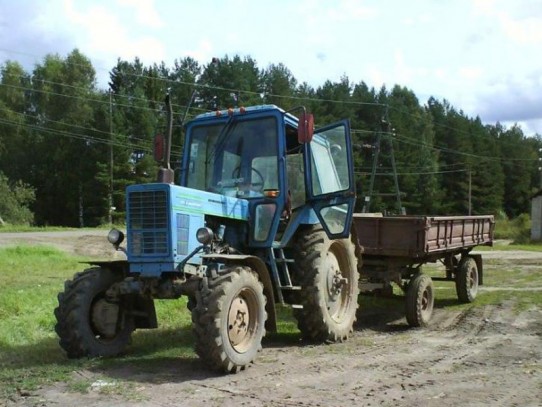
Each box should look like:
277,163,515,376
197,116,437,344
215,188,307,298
186,117,279,198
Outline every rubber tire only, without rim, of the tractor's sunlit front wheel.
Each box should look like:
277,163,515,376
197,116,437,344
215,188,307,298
192,267,267,373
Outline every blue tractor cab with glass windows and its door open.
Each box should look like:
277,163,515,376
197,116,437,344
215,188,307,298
181,105,354,252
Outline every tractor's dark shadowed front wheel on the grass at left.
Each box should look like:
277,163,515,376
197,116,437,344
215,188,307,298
55,267,135,358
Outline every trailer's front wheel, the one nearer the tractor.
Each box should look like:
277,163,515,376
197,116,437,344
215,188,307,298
406,273,434,327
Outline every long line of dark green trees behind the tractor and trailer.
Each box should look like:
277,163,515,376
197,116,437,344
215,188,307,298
0,49,542,227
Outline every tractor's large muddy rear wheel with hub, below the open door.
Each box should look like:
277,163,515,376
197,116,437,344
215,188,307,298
292,228,359,342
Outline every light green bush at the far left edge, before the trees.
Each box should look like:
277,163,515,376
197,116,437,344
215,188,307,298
0,173,36,226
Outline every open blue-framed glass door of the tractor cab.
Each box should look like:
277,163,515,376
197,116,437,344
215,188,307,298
304,120,356,239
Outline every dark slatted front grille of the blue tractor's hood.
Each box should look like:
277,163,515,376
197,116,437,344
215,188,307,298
128,190,169,256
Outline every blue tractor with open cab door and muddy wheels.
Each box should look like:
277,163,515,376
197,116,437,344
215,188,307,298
55,105,360,372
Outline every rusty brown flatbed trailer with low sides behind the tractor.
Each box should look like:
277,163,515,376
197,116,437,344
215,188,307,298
352,213,495,327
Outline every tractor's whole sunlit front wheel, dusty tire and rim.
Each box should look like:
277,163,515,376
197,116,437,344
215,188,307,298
192,267,267,373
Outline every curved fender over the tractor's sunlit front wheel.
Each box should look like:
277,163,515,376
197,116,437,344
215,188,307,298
201,253,277,332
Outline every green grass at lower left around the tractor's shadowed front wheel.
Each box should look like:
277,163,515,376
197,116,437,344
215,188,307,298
0,246,196,404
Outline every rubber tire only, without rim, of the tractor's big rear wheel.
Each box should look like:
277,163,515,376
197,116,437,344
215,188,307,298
292,227,359,342
